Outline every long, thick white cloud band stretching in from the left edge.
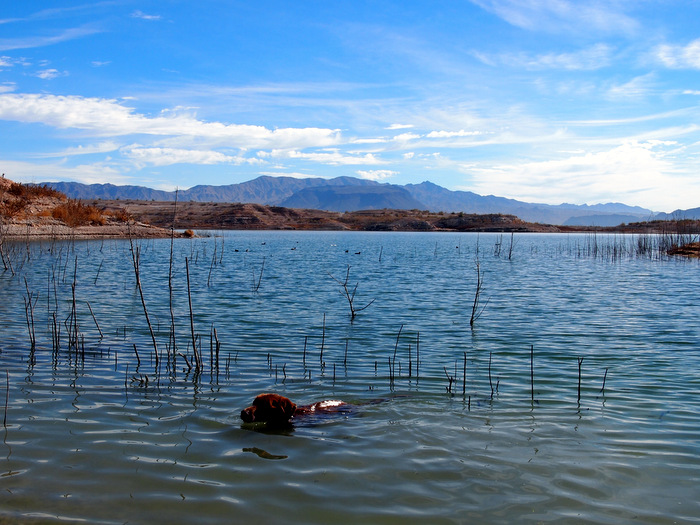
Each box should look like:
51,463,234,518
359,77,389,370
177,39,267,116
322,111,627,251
0,94,340,149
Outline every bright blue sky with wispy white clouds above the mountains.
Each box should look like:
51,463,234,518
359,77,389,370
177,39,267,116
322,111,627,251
0,0,700,211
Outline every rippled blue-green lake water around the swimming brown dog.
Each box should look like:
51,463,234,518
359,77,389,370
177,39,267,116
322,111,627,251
0,232,700,523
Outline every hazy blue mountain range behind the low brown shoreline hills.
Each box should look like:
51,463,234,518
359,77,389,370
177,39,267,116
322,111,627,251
43,175,656,226
